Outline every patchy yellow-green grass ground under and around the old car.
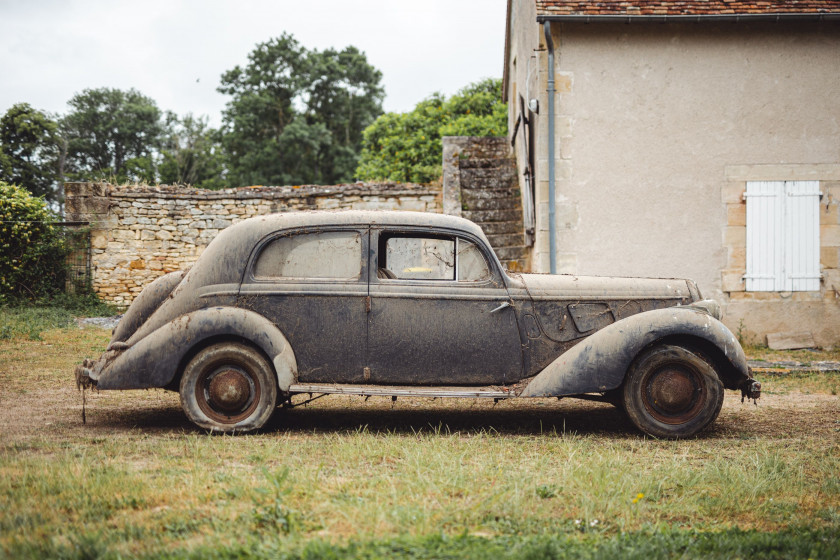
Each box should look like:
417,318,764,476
0,318,840,560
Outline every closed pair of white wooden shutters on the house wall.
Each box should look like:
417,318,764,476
744,181,820,292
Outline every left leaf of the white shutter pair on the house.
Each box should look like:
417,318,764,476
745,181,784,292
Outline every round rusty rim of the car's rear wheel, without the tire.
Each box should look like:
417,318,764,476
195,365,261,424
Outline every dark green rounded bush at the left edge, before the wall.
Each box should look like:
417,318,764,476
0,181,67,303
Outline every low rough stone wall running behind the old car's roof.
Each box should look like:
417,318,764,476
65,183,443,306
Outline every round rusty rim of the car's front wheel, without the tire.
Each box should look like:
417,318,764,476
642,363,706,424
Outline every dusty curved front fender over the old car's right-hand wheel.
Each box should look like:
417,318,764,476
520,307,749,397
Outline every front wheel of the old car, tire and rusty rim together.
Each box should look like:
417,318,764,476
622,344,723,439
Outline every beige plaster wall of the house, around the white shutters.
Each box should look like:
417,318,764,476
507,18,840,345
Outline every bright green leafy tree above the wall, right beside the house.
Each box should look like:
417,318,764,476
356,79,507,183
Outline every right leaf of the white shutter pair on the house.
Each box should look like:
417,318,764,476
784,181,820,292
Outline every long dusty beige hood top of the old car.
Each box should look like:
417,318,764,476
510,274,701,303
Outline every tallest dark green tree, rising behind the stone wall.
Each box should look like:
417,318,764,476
218,34,384,185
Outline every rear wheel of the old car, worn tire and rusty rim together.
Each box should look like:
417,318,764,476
180,342,277,433
